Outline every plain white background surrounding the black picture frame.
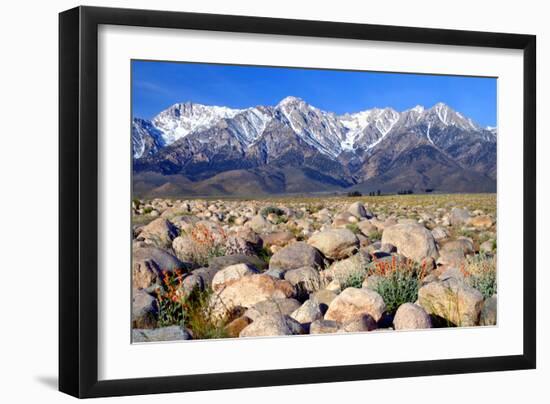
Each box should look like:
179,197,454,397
0,0,550,404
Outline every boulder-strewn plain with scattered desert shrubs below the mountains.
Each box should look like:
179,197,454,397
132,195,497,342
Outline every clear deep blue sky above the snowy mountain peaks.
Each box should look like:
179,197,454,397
132,61,497,126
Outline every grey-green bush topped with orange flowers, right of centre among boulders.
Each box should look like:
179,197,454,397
369,256,432,314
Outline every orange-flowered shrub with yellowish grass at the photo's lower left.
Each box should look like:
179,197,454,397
157,271,229,339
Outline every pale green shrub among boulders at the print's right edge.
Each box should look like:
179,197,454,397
462,254,497,299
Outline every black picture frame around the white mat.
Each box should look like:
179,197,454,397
59,7,536,398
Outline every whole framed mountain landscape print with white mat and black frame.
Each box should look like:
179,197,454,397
59,7,536,397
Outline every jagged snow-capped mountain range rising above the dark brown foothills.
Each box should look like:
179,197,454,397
132,96,496,191
